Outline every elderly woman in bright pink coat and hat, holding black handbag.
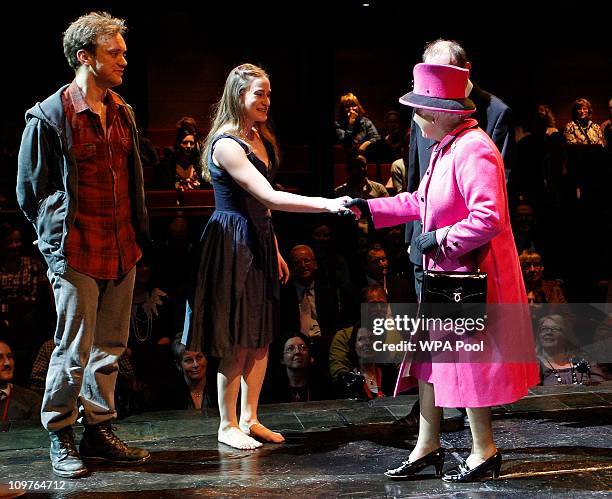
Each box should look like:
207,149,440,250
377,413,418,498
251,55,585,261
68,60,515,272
347,63,539,482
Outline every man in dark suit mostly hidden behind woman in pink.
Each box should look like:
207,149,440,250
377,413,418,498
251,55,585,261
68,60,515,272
406,39,514,296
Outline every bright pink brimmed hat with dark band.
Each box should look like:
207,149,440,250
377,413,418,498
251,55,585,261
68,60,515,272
399,63,476,114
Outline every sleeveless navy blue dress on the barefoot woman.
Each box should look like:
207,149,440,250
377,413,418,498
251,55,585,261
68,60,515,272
182,134,280,358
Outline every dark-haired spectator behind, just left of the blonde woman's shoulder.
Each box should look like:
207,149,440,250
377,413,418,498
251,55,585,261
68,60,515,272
159,118,203,191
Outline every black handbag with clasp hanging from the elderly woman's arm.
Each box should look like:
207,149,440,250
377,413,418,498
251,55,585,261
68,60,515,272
421,226,487,328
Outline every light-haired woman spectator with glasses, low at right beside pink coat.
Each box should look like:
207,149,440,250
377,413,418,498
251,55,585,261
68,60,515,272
536,314,605,385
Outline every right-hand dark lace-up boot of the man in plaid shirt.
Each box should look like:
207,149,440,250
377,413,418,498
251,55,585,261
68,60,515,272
79,423,151,466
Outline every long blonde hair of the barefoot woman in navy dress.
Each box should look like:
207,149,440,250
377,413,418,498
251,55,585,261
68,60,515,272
200,64,280,182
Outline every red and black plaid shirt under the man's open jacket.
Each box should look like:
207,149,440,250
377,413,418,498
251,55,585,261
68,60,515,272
62,81,142,279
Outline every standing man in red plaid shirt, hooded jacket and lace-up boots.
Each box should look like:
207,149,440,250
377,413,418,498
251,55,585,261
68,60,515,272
17,13,150,478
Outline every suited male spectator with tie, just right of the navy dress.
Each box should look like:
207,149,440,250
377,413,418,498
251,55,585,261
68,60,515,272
281,245,339,360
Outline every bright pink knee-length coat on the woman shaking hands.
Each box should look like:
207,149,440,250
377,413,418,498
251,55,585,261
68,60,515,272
368,119,539,407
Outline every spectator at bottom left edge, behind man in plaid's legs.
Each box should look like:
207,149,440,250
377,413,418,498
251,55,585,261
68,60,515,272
0,340,42,424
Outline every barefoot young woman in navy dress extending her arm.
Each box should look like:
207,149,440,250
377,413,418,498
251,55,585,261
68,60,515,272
182,64,350,449
